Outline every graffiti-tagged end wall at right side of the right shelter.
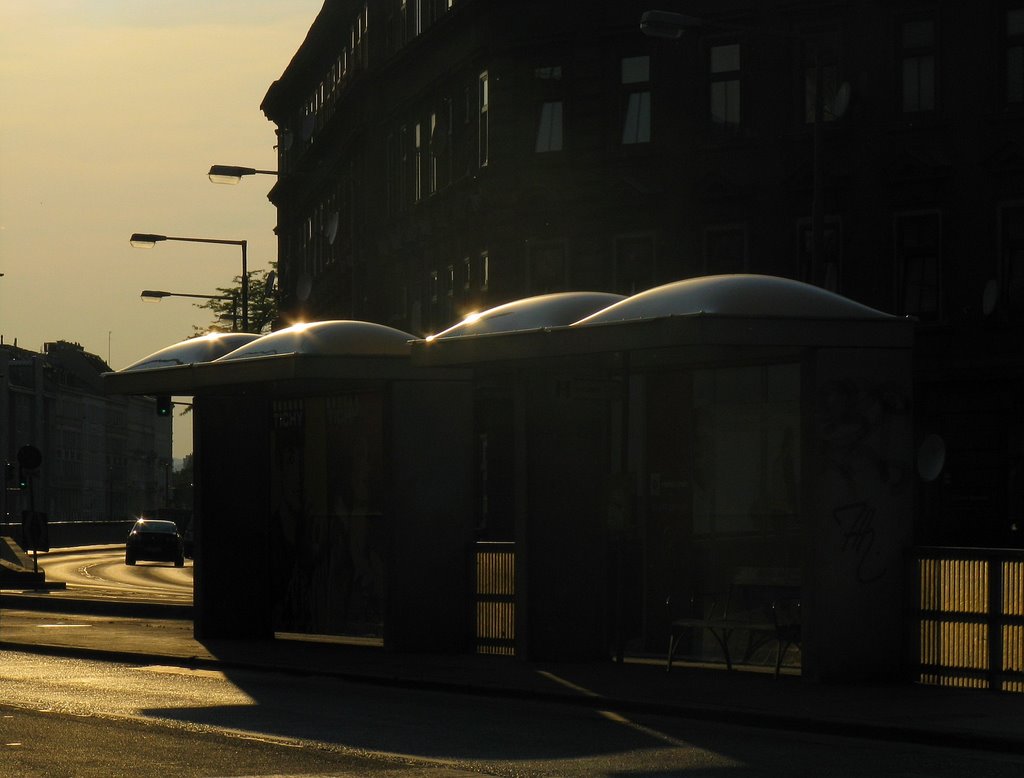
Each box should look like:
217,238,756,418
802,348,915,681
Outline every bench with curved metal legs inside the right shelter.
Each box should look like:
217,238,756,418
666,567,801,678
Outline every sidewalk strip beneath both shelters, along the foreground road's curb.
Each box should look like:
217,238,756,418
0,592,1024,754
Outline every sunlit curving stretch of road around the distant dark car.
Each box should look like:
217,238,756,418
33,546,193,605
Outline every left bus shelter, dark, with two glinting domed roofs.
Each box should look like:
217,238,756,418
104,321,473,651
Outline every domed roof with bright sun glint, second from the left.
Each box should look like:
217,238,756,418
217,320,416,362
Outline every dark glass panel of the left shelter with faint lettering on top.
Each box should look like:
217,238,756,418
271,392,387,639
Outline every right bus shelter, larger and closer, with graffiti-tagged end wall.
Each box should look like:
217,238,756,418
412,275,914,679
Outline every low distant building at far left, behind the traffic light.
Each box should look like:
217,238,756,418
0,341,172,523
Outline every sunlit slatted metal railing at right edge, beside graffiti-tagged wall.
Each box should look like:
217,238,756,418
911,548,1024,692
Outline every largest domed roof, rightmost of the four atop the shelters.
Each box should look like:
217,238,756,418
573,274,893,327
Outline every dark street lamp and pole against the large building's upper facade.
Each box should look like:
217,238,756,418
640,10,835,287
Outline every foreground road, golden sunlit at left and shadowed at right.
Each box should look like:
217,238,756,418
0,651,1024,778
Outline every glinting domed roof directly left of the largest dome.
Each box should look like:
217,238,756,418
427,292,626,340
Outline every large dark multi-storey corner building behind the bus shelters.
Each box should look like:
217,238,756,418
262,0,1024,546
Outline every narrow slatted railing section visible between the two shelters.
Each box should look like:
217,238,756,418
475,543,515,656
